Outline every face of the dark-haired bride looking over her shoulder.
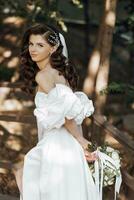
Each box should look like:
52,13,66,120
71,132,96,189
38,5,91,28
29,34,54,62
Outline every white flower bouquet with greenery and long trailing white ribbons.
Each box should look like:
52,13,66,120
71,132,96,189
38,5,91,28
87,143,122,200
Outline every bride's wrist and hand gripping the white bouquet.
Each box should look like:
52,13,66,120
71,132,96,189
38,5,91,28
77,137,97,162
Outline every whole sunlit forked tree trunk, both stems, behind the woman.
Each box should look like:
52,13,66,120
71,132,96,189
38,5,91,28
83,0,117,113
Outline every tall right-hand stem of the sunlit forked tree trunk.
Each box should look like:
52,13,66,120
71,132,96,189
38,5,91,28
95,0,117,114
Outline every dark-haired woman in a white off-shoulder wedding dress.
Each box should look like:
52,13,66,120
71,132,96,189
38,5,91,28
16,24,97,200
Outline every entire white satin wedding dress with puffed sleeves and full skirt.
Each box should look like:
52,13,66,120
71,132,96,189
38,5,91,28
20,83,97,200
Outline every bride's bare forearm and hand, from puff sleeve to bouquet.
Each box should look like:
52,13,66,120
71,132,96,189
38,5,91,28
64,118,96,161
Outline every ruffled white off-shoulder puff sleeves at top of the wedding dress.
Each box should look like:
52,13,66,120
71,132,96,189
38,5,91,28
34,84,94,130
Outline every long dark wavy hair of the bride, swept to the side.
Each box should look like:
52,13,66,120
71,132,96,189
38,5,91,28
20,24,78,96
